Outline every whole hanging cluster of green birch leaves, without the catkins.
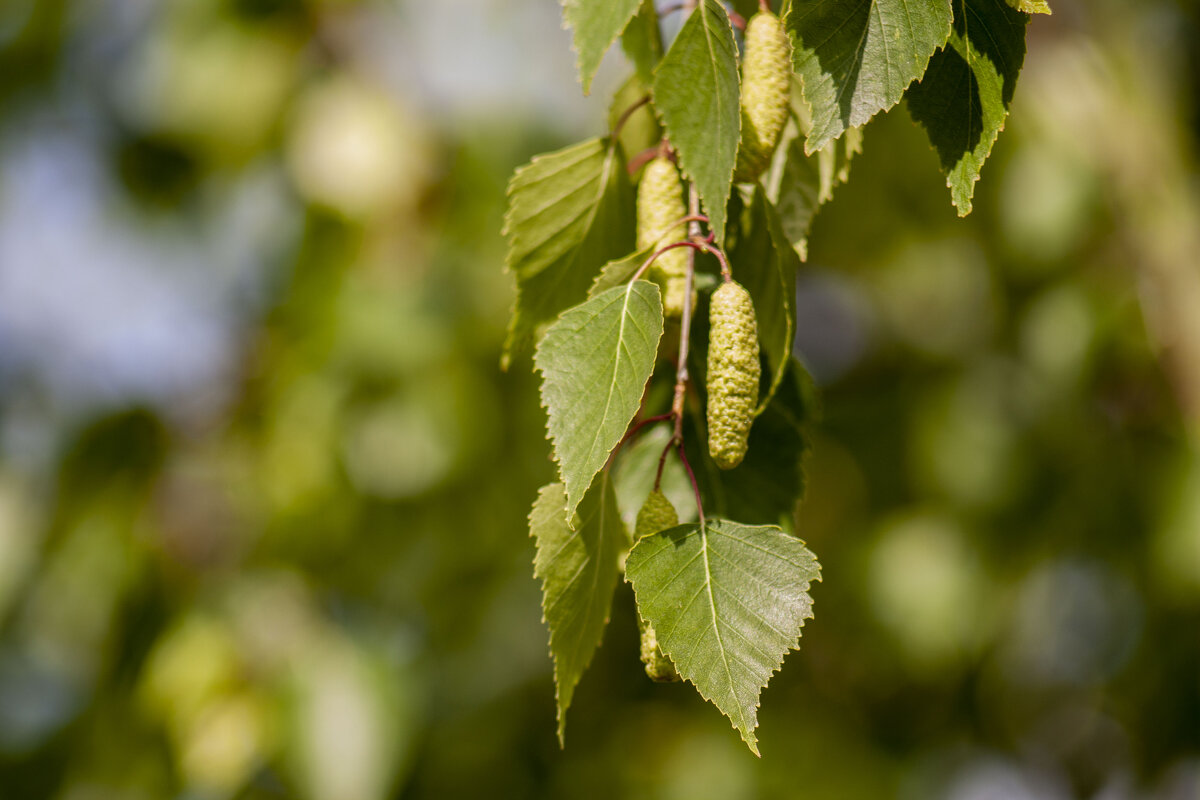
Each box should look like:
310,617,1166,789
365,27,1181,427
504,0,1050,753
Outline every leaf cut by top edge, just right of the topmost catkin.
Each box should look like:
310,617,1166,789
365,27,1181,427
786,0,953,152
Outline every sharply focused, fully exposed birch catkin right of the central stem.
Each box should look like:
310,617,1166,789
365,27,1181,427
708,281,762,469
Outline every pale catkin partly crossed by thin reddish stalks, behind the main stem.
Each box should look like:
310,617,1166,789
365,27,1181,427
637,156,688,319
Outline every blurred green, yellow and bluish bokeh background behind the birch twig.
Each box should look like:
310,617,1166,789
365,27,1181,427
0,0,1200,800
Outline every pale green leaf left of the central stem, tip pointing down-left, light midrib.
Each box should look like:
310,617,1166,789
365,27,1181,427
534,281,662,518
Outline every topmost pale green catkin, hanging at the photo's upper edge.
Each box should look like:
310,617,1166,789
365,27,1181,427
733,11,792,182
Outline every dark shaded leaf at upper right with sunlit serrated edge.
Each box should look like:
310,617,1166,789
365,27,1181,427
908,0,1030,217
